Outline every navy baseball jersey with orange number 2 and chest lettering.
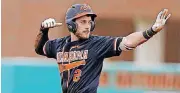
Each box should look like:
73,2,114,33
45,35,122,93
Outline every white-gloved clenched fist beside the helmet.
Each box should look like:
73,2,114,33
41,18,56,28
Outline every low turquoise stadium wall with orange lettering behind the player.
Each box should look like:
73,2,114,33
1,57,180,93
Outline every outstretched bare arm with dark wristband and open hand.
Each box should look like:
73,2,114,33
119,9,171,51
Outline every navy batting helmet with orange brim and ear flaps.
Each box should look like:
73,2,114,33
66,4,97,33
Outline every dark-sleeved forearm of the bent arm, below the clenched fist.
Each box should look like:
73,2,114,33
34,28,49,55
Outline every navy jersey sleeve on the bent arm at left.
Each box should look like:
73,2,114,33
44,39,58,58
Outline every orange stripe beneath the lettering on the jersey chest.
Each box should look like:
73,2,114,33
58,61,86,72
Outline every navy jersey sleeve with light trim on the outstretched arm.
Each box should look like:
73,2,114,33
97,36,122,58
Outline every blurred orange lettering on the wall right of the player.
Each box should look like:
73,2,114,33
100,71,180,90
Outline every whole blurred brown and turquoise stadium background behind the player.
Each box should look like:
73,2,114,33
1,0,180,93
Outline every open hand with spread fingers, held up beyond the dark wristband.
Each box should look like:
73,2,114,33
152,9,171,32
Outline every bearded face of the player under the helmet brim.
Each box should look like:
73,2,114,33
75,16,92,39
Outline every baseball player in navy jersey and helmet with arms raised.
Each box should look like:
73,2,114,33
35,4,170,93
